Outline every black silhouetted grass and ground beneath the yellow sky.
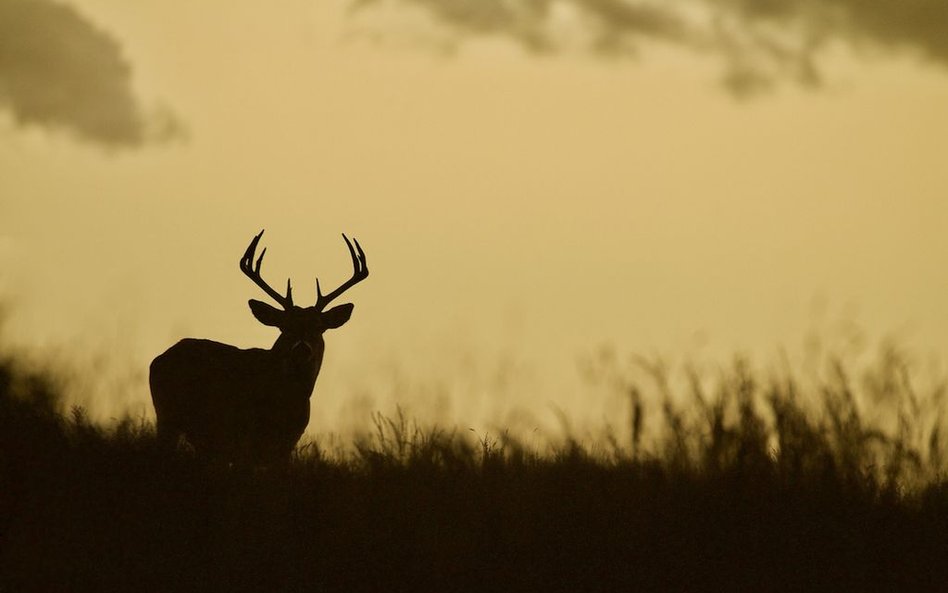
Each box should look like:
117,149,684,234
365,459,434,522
0,342,948,592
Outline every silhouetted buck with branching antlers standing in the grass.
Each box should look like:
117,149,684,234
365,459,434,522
149,231,369,463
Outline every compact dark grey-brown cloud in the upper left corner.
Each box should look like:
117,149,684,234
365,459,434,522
0,0,181,148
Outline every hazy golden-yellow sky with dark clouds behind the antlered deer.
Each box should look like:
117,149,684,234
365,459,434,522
0,0,948,432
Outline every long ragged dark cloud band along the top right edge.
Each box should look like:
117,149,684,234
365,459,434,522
352,0,948,94
